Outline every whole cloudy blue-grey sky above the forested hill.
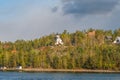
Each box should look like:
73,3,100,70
0,0,120,42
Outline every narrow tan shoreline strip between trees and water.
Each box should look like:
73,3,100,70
0,68,120,73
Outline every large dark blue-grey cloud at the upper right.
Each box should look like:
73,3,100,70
61,0,119,15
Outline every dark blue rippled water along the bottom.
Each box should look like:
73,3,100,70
0,72,120,80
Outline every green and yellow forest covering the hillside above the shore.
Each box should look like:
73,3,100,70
0,29,120,70
